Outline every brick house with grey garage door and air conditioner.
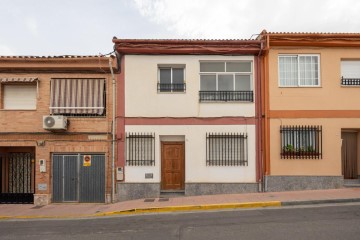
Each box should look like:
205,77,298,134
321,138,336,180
0,56,116,205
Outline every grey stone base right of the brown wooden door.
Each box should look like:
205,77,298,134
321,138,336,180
185,183,259,196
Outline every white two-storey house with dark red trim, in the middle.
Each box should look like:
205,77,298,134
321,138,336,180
113,38,262,200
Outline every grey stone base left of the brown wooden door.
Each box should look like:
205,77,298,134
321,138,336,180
117,183,160,201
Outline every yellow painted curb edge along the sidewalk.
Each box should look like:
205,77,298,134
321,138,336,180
0,201,281,220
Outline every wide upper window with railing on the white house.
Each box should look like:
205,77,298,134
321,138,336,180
200,61,253,102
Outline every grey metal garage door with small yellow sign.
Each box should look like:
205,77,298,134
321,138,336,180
53,154,105,203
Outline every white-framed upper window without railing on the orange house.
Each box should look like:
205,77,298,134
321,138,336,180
279,54,320,87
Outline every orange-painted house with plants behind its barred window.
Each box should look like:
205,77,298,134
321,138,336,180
259,31,360,191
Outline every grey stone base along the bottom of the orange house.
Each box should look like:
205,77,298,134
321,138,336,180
265,176,344,192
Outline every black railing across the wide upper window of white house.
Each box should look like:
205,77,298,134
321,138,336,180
199,91,254,102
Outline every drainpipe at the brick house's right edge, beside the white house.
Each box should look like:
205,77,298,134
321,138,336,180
109,56,116,203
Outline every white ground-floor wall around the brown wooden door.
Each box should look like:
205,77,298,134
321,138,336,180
125,125,256,183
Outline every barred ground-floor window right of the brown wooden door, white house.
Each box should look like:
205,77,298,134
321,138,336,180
206,133,248,166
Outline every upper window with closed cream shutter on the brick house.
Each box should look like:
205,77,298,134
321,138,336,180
0,78,38,110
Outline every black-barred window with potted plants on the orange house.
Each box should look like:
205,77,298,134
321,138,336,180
280,126,322,159
